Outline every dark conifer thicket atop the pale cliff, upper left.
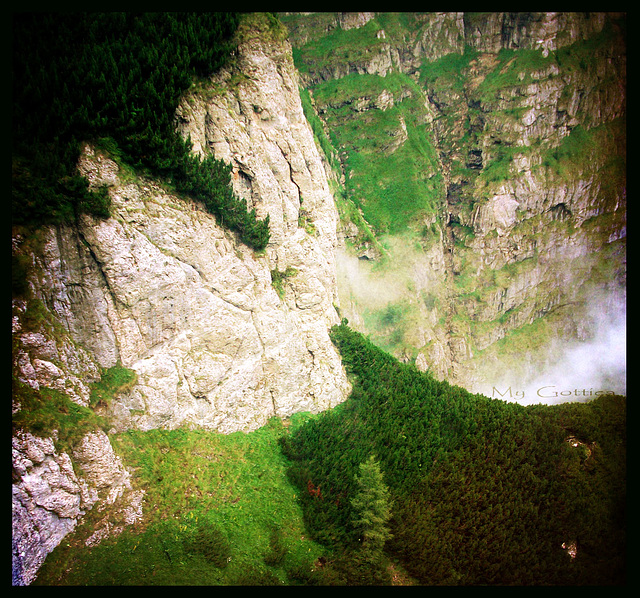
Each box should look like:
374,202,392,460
12,12,269,249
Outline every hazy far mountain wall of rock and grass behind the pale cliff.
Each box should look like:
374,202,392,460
282,12,626,393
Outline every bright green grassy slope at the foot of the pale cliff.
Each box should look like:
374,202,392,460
34,418,326,586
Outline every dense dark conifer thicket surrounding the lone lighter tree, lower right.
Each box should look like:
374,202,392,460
283,321,626,585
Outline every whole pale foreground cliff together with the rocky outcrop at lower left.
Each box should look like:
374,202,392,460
13,19,349,583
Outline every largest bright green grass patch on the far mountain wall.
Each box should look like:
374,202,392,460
306,73,444,236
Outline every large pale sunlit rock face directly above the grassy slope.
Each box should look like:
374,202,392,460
17,17,348,432
